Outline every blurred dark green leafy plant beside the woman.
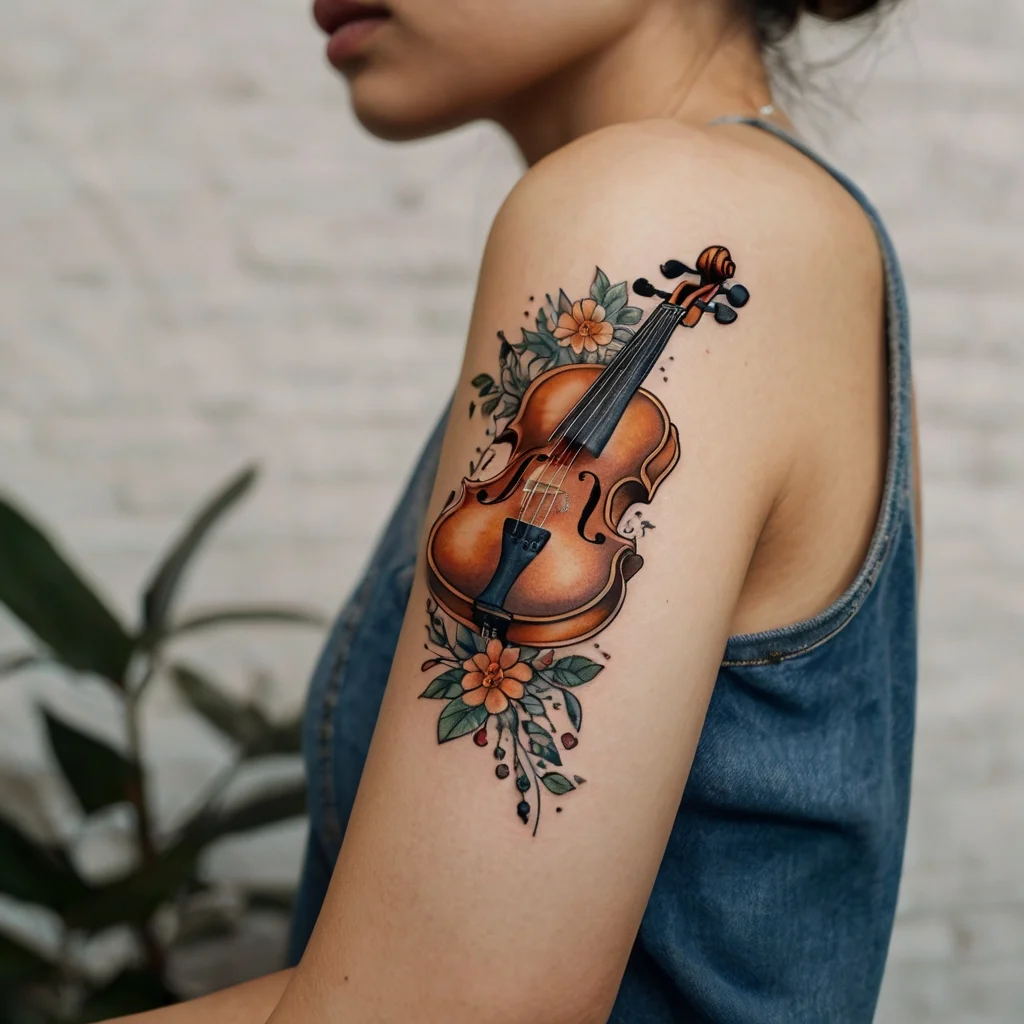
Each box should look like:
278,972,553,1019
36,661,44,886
0,467,323,1024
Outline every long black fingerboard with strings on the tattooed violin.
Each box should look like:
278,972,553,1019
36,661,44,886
551,302,686,457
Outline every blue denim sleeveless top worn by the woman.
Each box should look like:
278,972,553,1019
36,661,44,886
292,118,916,1024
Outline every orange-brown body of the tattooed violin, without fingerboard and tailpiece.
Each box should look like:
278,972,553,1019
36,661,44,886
426,364,679,647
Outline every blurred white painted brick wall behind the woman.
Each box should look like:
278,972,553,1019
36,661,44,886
0,0,1024,1024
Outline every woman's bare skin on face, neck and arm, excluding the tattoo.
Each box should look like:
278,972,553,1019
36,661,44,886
105,0,921,1024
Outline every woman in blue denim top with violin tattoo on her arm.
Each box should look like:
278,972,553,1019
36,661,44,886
116,0,916,1024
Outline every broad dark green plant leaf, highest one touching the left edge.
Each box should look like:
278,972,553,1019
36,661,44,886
0,500,133,686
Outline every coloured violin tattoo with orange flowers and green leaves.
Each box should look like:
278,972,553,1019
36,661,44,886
421,246,750,836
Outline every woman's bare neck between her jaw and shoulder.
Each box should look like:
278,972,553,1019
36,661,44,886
493,0,771,165
